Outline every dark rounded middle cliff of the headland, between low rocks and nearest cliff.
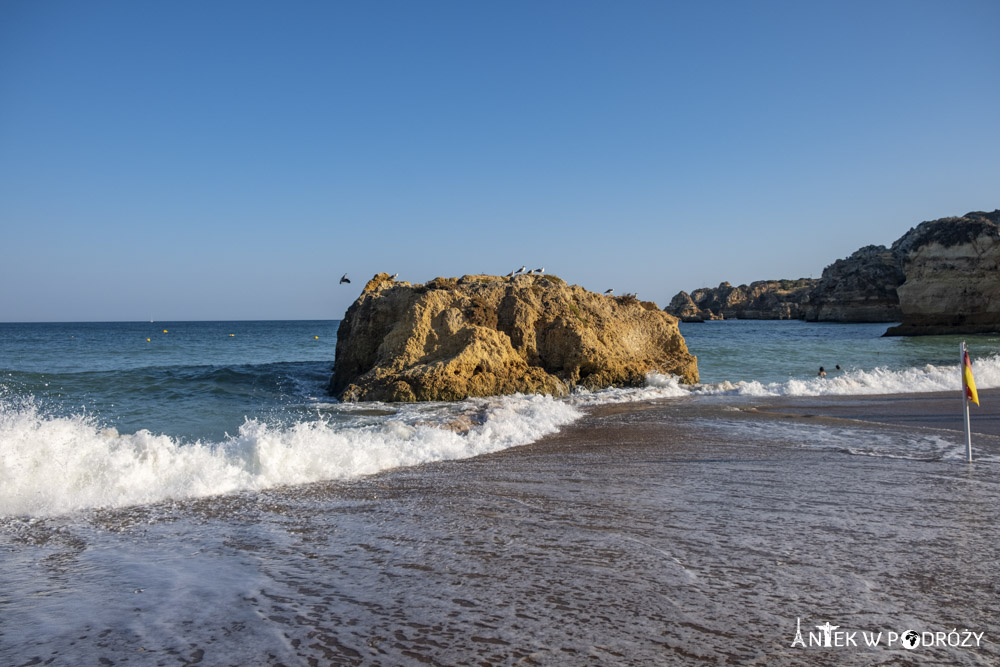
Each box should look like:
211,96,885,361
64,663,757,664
804,245,904,322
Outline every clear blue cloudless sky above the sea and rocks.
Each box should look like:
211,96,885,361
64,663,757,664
0,0,1000,321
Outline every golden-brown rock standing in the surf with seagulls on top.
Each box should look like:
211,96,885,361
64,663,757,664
330,273,698,401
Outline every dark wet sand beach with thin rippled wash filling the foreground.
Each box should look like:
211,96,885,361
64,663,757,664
0,392,1000,665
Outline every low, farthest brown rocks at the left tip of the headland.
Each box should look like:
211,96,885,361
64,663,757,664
665,278,819,322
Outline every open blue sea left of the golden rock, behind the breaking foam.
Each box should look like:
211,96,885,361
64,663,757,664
0,320,339,439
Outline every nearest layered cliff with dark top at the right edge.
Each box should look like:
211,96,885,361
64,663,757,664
886,210,1000,336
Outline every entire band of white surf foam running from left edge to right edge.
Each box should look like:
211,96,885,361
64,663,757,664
7,355,1000,516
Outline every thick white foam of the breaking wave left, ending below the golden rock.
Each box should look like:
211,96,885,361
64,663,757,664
0,396,580,516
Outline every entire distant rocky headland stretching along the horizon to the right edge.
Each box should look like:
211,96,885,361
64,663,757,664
666,210,1000,335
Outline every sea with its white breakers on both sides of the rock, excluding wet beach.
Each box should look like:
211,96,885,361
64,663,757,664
0,321,1000,516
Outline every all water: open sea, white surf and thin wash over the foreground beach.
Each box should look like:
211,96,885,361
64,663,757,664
0,321,1000,665
